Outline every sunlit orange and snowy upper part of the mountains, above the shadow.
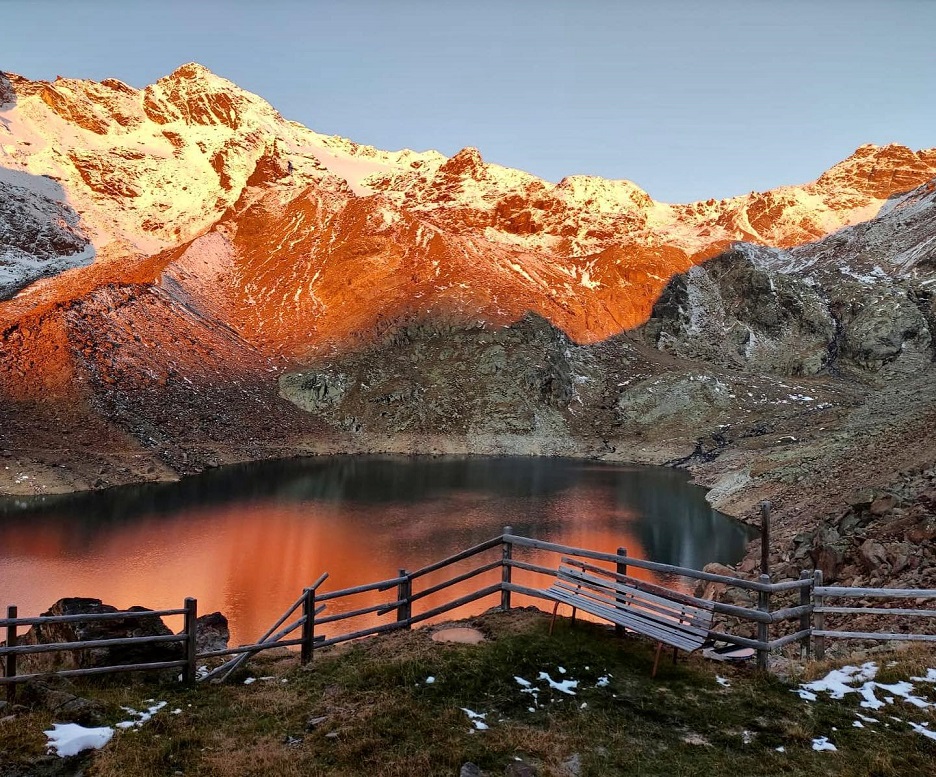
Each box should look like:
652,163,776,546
0,64,936,348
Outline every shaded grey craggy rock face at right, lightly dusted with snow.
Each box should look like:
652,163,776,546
640,195,936,375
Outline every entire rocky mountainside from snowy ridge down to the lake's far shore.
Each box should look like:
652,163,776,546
0,64,936,588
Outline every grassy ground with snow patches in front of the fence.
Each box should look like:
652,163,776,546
0,611,936,777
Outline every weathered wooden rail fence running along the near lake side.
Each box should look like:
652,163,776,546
0,526,936,687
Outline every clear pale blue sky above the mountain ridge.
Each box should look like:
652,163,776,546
0,0,936,202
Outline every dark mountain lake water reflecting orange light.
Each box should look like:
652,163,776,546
0,456,753,644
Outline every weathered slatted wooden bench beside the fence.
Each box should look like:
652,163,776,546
543,558,714,677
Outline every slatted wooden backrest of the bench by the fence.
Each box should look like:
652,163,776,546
555,558,714,644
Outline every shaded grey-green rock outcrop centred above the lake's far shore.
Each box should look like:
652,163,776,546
280,315,583,452
